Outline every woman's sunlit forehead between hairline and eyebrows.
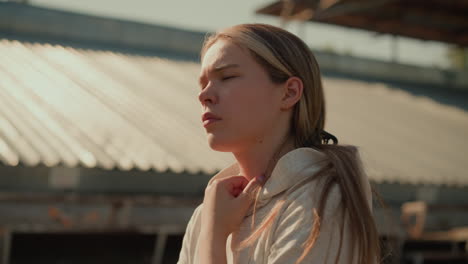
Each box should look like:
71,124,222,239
201,39,251,71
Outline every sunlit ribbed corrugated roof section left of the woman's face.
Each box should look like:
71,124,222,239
0,40,232,173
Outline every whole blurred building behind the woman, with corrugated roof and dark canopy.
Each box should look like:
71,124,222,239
0,0,468,264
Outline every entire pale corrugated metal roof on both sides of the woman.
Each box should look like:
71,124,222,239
0,39,468,185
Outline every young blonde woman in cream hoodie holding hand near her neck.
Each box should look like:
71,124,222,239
178,24,380,264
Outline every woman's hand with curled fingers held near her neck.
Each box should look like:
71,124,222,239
201,176,262,238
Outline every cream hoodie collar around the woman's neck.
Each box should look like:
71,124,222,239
208,147,328,215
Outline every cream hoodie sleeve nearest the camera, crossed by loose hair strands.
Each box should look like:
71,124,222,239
267,185,352,264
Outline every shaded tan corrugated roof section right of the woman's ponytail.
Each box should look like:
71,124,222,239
324,78,468,185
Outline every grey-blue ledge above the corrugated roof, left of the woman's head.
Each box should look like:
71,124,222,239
0,3,206,57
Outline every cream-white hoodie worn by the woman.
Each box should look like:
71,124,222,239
177,147,372,264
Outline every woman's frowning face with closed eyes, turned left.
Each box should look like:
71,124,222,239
199,39,282,152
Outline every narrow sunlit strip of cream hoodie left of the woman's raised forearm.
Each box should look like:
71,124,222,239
177,204,203,264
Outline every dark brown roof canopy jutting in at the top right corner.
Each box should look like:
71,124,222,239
256,0,468,46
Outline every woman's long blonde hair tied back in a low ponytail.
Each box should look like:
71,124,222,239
201,24,380,264
